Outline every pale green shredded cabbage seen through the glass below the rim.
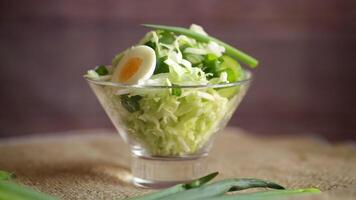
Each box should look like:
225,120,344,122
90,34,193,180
118,86,233,156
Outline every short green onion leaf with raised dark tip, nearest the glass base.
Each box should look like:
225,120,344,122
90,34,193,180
130,172,219,200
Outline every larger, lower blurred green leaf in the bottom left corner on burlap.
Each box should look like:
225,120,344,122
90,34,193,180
0,180,56,200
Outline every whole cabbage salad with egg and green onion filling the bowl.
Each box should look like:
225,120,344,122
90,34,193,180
85,24,258,156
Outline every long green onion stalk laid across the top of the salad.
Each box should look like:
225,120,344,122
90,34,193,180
143,24,258,68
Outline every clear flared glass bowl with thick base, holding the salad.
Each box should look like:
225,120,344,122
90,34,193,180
87,71,252,188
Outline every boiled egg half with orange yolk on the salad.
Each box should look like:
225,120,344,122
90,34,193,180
111,45,156,84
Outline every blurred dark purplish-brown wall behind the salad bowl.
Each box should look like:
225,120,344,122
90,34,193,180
0,0,356,140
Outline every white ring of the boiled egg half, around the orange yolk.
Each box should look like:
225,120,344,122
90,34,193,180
111,45,156,84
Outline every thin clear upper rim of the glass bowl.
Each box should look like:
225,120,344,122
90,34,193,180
84,69,253,89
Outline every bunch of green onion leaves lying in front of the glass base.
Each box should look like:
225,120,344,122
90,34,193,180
130,172,321,200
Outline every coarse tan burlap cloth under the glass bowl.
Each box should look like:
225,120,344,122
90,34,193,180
0,128,356,200
